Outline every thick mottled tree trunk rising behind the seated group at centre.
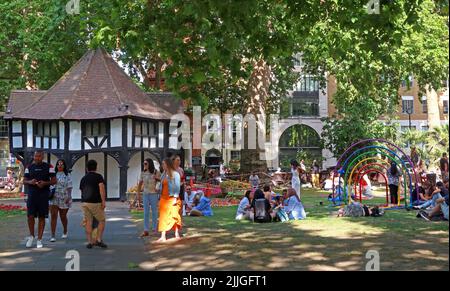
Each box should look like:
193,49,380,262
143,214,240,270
241,59,270,178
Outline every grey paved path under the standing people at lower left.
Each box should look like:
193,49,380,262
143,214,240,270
0,202,148,271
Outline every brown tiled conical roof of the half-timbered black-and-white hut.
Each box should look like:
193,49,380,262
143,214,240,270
5,48,176,120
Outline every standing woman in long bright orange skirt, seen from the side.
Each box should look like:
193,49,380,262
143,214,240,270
158,158,181,242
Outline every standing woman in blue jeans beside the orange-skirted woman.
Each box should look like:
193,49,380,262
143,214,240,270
137,159,160,238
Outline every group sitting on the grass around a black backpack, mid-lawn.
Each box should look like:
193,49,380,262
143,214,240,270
236,186,306,222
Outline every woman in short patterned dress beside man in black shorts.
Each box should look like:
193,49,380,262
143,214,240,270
49,159,72,242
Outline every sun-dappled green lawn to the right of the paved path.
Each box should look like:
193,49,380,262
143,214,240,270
134,190,449,270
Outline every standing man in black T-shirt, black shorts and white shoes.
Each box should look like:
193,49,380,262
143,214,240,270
23,151,56,248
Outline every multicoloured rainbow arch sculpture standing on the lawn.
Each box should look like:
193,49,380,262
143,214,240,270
332,139,418,208
